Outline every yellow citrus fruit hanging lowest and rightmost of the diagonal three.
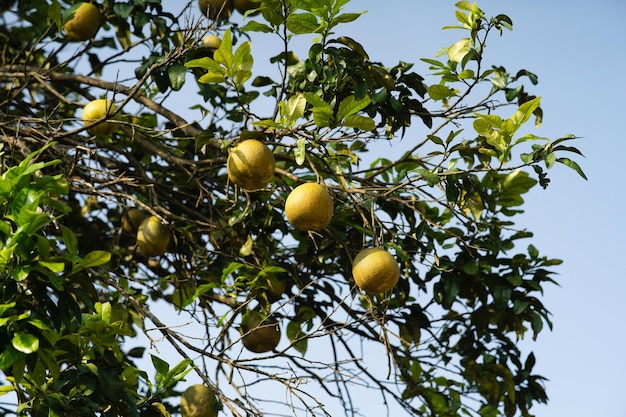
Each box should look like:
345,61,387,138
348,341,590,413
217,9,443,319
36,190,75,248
352,247,400,294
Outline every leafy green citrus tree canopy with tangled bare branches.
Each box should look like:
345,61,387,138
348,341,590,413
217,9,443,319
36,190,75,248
0,0,585,417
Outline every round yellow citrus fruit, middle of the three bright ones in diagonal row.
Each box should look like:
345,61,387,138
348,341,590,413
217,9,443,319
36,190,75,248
285,182,333,230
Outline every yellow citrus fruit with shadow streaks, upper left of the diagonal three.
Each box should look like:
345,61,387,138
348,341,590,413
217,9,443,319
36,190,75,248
226,139,276,191
